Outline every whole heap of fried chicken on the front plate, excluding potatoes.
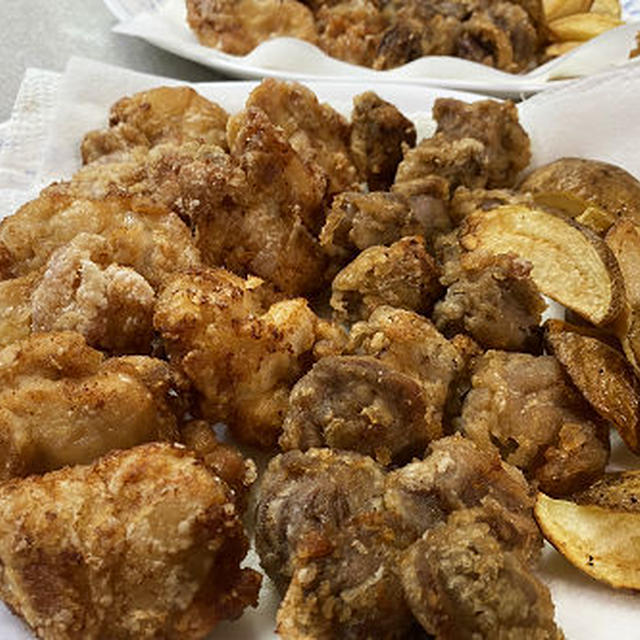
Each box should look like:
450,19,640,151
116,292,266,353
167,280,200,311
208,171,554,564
0,80,609,640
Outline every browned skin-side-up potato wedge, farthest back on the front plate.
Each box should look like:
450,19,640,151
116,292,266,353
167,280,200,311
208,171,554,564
520,158,640,232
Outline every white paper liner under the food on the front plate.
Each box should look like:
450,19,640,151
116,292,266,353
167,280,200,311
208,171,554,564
0,59,640,640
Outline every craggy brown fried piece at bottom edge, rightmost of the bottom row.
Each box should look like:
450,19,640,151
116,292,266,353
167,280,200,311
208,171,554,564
401,511,564,640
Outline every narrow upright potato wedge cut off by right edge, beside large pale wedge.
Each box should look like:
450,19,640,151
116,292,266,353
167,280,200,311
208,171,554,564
605,218,640,374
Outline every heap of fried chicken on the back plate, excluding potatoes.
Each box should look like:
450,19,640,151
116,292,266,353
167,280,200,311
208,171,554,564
186,0,548,73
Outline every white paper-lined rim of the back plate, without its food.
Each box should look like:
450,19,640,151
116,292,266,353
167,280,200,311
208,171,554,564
104,0,640,97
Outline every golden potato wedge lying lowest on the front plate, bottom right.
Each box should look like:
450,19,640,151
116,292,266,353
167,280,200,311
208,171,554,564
534,471,640,590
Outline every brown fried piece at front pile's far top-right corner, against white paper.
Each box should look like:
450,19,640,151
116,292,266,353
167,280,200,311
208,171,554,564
433,98,531,189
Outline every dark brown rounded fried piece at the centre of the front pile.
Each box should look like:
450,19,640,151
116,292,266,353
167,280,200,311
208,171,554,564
280,356,440,465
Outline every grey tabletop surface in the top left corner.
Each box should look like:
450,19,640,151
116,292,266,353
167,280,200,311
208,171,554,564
0,0,228,122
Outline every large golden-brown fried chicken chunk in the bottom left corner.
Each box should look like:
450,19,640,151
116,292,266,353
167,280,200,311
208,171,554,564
0,444,260,640
